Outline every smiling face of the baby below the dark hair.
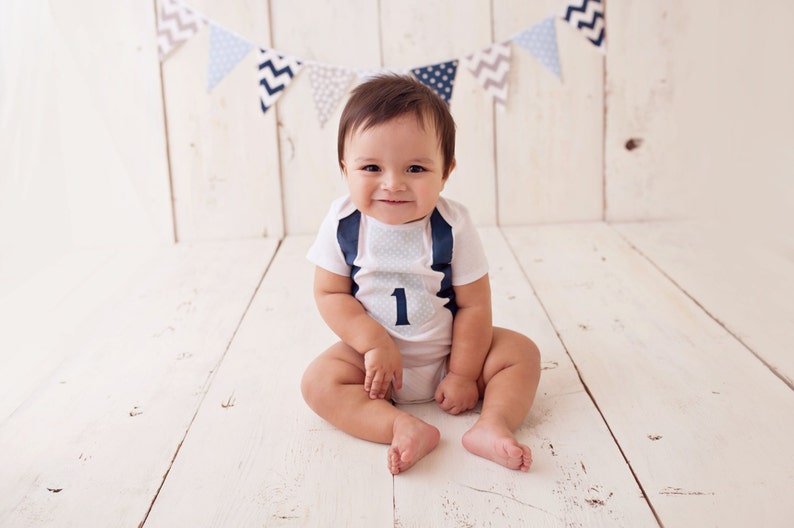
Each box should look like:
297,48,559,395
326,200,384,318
342,114,446,225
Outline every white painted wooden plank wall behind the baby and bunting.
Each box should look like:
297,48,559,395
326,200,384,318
0,0,794,245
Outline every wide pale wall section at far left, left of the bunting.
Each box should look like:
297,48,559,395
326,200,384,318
0,0,173,251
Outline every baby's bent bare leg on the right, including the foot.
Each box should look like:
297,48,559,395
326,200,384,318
463,328,540,471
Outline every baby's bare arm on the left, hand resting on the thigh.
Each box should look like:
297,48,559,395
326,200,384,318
314,266,403,399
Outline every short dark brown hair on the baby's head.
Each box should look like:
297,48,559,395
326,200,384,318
337,74,455,176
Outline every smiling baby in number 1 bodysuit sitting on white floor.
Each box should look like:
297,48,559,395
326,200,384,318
301,75,540,474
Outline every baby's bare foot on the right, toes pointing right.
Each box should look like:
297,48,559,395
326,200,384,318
463,420,532,471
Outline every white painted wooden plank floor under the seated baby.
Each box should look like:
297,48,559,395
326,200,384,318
0,223,794,528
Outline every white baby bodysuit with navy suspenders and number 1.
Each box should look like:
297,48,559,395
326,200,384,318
307,196,488,403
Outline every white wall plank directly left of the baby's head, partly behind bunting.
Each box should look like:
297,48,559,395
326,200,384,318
270,0,380,234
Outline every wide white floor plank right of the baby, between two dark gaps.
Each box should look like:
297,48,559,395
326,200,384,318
505,224,794,526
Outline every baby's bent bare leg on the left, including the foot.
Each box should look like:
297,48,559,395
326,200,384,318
301,342,439,474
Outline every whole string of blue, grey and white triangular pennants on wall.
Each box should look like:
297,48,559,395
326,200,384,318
157,0,606,119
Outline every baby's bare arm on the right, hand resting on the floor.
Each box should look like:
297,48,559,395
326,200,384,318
436,275,493,414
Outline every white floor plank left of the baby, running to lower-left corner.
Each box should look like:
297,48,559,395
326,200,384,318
0,240,277,527
